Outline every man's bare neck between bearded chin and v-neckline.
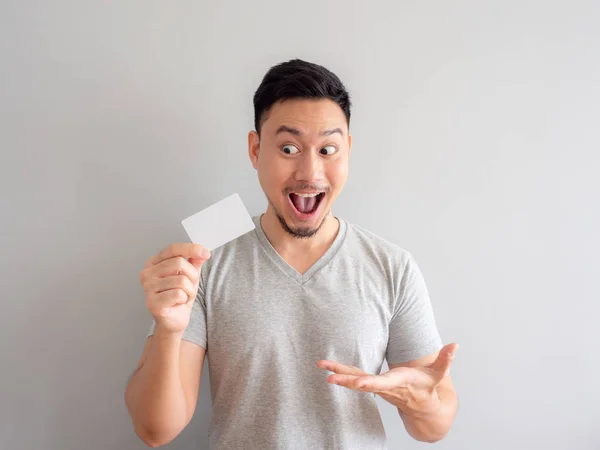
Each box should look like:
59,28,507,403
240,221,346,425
261,205,340,255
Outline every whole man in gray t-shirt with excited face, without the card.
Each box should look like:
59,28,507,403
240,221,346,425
126,60,457,450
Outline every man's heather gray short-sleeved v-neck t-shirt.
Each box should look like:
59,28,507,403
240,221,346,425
150,216,442,450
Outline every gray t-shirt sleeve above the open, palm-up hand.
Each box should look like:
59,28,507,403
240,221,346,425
386,252,443,364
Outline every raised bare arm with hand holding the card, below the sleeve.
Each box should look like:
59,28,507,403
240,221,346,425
125,243,210,447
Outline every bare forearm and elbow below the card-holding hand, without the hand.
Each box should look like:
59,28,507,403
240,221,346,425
125,328,206,447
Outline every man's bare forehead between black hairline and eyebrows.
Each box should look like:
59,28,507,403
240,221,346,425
262,99,348,135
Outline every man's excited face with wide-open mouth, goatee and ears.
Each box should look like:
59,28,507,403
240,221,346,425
248,99,352,238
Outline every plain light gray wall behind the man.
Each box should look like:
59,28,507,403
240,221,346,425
0,0,600,450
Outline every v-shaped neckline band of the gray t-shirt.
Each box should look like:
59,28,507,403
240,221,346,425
252,215,347,284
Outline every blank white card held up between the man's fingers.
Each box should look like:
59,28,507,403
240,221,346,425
181,194,255,251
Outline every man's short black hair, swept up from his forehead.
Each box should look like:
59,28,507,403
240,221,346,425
254,59,352,135
